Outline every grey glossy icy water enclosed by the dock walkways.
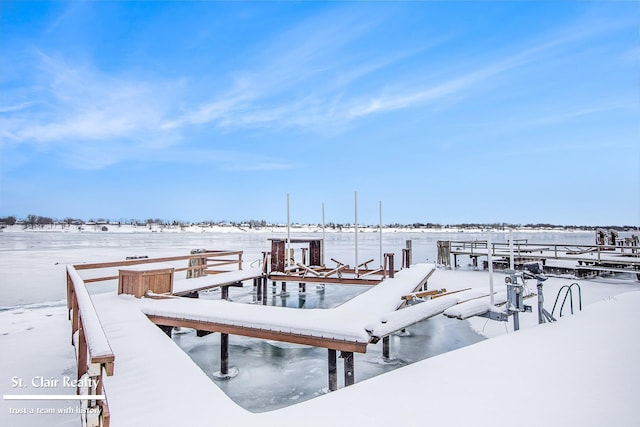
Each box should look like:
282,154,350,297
173,283,483,412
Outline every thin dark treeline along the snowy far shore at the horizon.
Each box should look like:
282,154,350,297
0,215,638,231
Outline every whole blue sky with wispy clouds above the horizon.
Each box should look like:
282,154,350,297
0,1,640,225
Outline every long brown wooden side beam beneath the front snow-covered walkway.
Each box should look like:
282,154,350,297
147,315,367,353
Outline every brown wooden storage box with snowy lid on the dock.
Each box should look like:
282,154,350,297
118,264,174,298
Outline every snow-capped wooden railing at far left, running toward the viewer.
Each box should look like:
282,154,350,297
67,266,115,426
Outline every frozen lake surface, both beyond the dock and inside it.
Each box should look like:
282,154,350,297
0,232,604,412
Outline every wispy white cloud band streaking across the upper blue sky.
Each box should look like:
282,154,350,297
0,4,636,169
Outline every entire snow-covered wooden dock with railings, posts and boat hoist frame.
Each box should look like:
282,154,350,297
67,239,504,425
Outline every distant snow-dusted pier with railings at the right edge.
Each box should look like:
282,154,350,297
437,234,640,280
